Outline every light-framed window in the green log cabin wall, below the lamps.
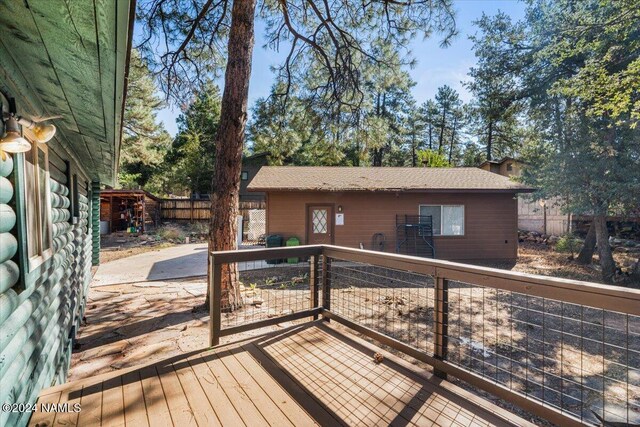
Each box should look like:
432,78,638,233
22,142,53,271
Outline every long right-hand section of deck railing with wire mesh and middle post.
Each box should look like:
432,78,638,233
323,247,640,425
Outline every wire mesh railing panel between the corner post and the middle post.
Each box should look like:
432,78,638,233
328,260,435,354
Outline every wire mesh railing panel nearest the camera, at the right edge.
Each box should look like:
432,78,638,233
446,281,640,424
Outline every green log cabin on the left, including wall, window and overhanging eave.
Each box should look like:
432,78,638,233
0,0,135,426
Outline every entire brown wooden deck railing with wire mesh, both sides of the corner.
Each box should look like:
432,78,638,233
210,245,640,425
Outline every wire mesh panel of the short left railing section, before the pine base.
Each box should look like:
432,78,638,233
220,258,312,329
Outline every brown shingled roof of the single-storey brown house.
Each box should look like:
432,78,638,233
248,166,534,193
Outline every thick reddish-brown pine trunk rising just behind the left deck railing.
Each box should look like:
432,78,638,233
205,0,256,311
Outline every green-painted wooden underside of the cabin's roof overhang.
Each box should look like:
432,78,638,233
0,0,135,185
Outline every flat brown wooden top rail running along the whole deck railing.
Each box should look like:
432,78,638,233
211,245,640,316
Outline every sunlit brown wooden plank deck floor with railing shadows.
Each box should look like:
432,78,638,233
30,321,531,427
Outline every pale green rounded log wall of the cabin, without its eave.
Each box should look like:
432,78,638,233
0,147,94,425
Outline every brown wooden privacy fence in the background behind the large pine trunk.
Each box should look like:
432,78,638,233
160,199,267,222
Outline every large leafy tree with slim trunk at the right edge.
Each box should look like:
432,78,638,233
478,0,640,281
